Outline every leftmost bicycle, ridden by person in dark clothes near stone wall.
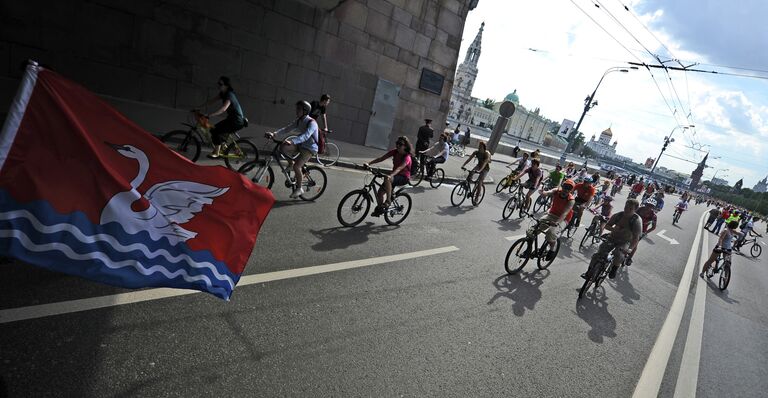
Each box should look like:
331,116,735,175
160,110,259,170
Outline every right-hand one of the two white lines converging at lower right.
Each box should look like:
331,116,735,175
675,230,709,398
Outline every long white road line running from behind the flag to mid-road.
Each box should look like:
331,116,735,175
0,246,459,324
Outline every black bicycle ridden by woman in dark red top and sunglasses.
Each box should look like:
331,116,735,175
336,168,412,227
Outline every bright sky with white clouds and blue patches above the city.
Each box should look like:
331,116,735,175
459,0,768,188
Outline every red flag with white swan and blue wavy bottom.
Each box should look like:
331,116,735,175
0,61,274,299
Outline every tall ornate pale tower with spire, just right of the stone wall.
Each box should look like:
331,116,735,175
448,22,485,122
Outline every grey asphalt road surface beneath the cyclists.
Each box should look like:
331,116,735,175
0,169,768,397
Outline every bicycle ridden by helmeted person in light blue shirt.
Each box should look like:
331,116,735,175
237,135,328,201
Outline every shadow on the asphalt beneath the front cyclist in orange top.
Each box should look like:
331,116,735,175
488,269,549,316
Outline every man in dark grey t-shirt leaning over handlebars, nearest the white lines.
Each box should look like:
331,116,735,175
581,199,642,279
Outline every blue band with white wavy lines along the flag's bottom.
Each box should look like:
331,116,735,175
0,190,239,299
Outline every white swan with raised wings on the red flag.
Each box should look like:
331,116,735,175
100,144,229,245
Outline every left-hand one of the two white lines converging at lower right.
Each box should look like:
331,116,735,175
632,212,707,398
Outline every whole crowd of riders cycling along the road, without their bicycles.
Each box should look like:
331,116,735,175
192,76,760,292
